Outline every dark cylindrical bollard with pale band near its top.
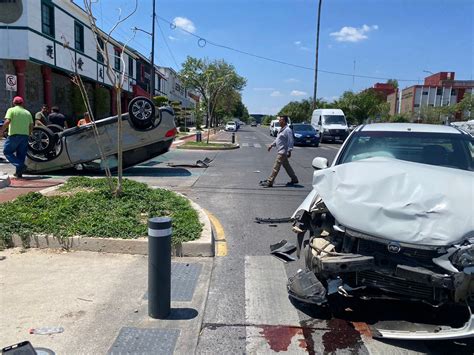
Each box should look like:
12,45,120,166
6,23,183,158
148,217,171,319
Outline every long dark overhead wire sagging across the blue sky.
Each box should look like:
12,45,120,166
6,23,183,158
156,15,417,81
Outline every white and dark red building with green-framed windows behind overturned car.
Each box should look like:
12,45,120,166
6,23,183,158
0,0,193,123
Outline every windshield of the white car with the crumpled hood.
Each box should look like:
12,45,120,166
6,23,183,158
337,131,474,171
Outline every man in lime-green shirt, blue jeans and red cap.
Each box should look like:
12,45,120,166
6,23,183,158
0,96,33,178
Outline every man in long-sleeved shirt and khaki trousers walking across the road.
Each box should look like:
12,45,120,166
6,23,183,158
260,116,298,187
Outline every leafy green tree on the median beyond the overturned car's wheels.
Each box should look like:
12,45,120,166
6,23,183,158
179,56,247,143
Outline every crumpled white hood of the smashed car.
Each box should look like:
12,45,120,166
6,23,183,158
297,158,474,246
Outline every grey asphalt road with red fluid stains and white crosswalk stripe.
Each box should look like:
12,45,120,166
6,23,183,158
171,126,473,354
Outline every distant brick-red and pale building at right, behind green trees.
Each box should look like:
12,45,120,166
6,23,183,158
387,72,474,119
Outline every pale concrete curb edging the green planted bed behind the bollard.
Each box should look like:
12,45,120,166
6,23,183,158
12,184,214,257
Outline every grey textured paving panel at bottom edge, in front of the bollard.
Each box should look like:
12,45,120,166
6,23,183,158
108,327,179,355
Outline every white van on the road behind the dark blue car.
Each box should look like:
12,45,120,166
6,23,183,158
311,108,349,142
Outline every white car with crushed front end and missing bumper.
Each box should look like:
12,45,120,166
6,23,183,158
288,124,474,340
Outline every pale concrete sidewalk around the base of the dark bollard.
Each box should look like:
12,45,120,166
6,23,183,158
0,248,213,354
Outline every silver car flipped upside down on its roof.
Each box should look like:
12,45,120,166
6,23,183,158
26,97,176,173
